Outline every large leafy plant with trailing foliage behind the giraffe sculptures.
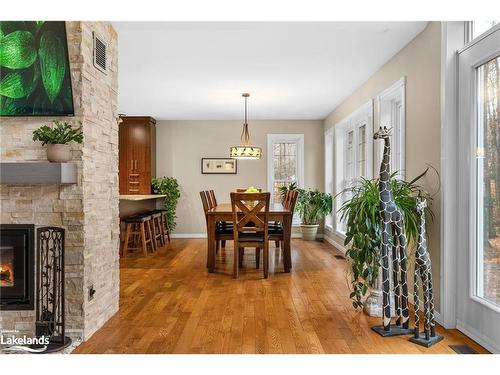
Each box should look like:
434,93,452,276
336,170,433,308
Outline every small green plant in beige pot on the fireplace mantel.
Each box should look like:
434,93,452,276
33,120,83,163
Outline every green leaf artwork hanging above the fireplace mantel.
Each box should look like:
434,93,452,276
0,21,74,116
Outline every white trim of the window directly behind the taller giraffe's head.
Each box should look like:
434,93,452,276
375,76,406,180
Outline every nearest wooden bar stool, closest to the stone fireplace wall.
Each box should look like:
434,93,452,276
122,214,156,256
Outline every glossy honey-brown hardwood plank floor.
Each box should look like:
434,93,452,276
74,239,487,354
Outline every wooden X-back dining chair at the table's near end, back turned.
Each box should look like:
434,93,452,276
231,193,271,279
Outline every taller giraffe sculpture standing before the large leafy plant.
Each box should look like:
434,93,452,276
372,126,413,336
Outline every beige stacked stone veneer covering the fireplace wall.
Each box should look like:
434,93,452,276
0,22,119,339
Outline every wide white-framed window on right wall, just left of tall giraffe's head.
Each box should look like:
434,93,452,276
334,101,373,235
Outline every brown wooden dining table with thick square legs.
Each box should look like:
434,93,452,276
207,203,292,273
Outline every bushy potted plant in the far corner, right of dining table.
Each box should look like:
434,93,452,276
296,189,332,240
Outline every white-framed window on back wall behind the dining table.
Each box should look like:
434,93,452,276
267,134,304,224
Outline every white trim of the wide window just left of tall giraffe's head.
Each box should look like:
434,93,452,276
332,100,373,238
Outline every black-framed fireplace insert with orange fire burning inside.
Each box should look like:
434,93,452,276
0,224,35,310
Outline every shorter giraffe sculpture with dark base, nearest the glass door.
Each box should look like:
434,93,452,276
410,197,443,347
